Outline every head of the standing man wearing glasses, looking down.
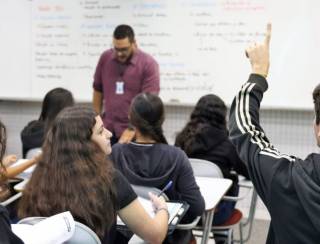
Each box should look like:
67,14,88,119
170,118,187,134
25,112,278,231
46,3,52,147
113,25,135,63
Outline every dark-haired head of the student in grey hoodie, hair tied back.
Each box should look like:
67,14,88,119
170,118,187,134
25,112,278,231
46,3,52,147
129,93,167,144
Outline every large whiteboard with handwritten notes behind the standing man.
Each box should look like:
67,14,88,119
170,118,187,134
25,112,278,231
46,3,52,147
0,0,320,109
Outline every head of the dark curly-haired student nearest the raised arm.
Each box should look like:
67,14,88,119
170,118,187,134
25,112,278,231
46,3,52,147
190,94,227,129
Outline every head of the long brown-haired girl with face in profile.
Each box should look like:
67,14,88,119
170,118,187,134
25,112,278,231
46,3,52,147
44,106,112,155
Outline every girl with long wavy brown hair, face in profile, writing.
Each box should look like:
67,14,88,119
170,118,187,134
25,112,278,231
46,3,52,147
19,106,168,244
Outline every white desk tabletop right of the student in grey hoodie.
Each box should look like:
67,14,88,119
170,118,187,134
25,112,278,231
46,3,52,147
195,176,232,211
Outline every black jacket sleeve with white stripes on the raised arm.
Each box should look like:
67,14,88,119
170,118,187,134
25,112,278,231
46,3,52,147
229,74,295,204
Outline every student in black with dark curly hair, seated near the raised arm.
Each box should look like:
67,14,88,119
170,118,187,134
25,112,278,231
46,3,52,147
175,94,249,225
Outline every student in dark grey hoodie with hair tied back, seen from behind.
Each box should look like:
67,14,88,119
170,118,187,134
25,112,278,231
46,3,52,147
111,93,204,241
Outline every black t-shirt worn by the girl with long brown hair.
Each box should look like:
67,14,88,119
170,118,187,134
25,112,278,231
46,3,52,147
102,170,137,244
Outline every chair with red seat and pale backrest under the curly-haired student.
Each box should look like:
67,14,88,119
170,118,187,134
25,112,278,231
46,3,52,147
189,158,254,244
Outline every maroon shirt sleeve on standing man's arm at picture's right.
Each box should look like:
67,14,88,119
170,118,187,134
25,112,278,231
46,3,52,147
142,59,160,94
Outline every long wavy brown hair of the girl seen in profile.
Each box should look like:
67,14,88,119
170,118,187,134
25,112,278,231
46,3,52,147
19,106,117,238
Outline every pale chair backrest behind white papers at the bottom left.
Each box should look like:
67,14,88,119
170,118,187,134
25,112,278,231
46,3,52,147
18,217,101,244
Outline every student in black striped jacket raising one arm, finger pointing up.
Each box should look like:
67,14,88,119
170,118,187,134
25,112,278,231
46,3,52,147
229,24,320,244
